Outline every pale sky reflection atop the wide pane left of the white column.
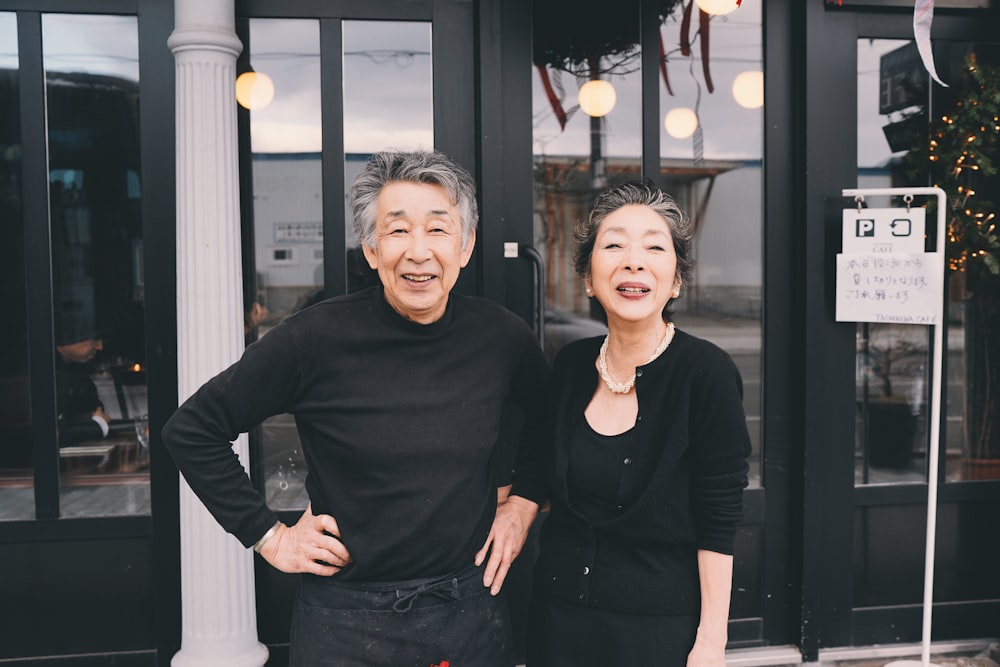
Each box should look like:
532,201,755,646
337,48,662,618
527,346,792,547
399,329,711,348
42,14,139,81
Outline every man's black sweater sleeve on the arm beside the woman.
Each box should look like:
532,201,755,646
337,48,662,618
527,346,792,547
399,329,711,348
511,328,551,504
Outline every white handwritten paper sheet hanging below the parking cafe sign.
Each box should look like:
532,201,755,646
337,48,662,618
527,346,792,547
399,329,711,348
837,252,944,325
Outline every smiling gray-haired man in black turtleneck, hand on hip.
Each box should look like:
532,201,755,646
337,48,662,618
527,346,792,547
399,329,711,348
163,152,548,667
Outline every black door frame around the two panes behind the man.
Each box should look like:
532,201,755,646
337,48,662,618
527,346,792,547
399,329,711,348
236,0,484,664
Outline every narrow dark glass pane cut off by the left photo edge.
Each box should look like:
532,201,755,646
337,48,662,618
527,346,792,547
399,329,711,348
0,12,35,519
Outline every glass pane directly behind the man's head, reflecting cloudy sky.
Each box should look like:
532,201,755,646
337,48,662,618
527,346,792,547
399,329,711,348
344,21,434,292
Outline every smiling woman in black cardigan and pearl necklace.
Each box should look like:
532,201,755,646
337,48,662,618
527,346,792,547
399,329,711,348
528,183,750,667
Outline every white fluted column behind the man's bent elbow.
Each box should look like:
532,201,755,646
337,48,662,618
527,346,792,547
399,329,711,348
168,0,268,667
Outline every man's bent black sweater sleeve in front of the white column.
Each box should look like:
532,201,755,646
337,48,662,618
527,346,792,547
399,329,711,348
163,325,301,547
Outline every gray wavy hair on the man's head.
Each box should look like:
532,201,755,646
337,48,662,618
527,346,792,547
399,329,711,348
351,150,479,249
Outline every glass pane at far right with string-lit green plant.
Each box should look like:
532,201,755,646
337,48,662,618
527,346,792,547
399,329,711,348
936,42,1000,480
